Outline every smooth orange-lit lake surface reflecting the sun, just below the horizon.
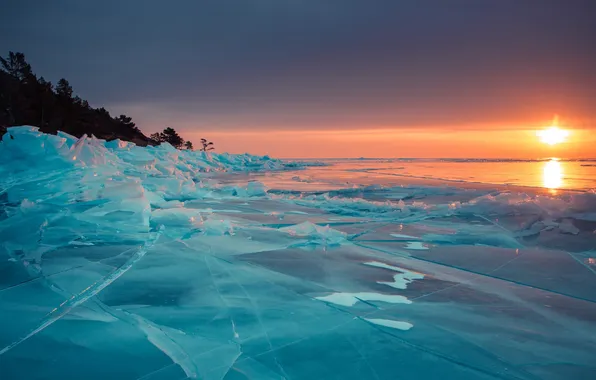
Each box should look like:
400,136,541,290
272,159,596,190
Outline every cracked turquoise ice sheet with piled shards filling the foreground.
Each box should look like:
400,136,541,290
0,127,596,380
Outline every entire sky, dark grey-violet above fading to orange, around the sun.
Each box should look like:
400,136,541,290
0,0,596,158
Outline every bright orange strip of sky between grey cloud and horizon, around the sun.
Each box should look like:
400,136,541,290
169,118,596,159
